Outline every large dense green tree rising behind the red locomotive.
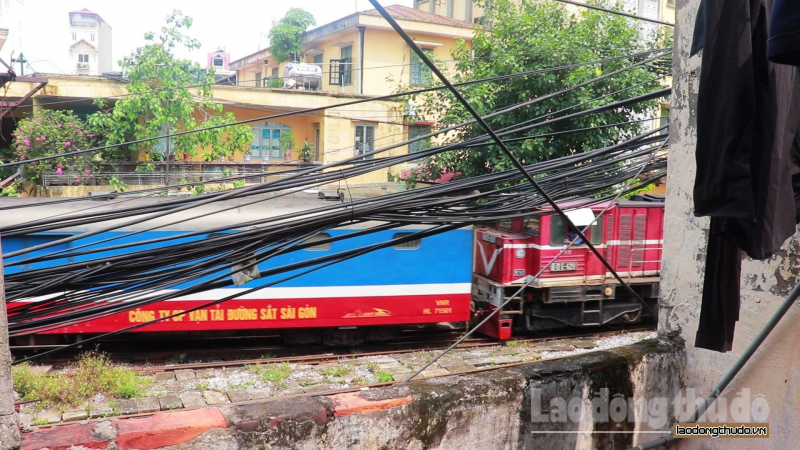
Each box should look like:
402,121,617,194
401,0,665,179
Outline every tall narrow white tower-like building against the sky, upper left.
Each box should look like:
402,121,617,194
69,8,112,75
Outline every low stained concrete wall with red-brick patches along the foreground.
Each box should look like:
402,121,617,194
23,339,684,450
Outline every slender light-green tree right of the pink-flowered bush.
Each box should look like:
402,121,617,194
88,11,252,162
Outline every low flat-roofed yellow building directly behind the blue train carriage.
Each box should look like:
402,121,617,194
1,74,409,183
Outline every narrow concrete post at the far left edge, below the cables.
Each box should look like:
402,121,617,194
0,236,20,450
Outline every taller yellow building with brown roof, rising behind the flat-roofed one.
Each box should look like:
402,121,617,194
230,5,474,95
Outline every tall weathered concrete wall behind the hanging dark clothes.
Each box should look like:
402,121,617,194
659,0,800,449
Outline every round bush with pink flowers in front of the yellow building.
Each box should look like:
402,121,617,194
12,109,104,185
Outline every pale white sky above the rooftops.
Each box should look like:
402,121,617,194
16,0,413,73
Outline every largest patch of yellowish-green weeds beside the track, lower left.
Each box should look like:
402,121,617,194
12,352,153,406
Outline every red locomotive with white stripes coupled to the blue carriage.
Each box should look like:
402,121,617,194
472,195,664,339
